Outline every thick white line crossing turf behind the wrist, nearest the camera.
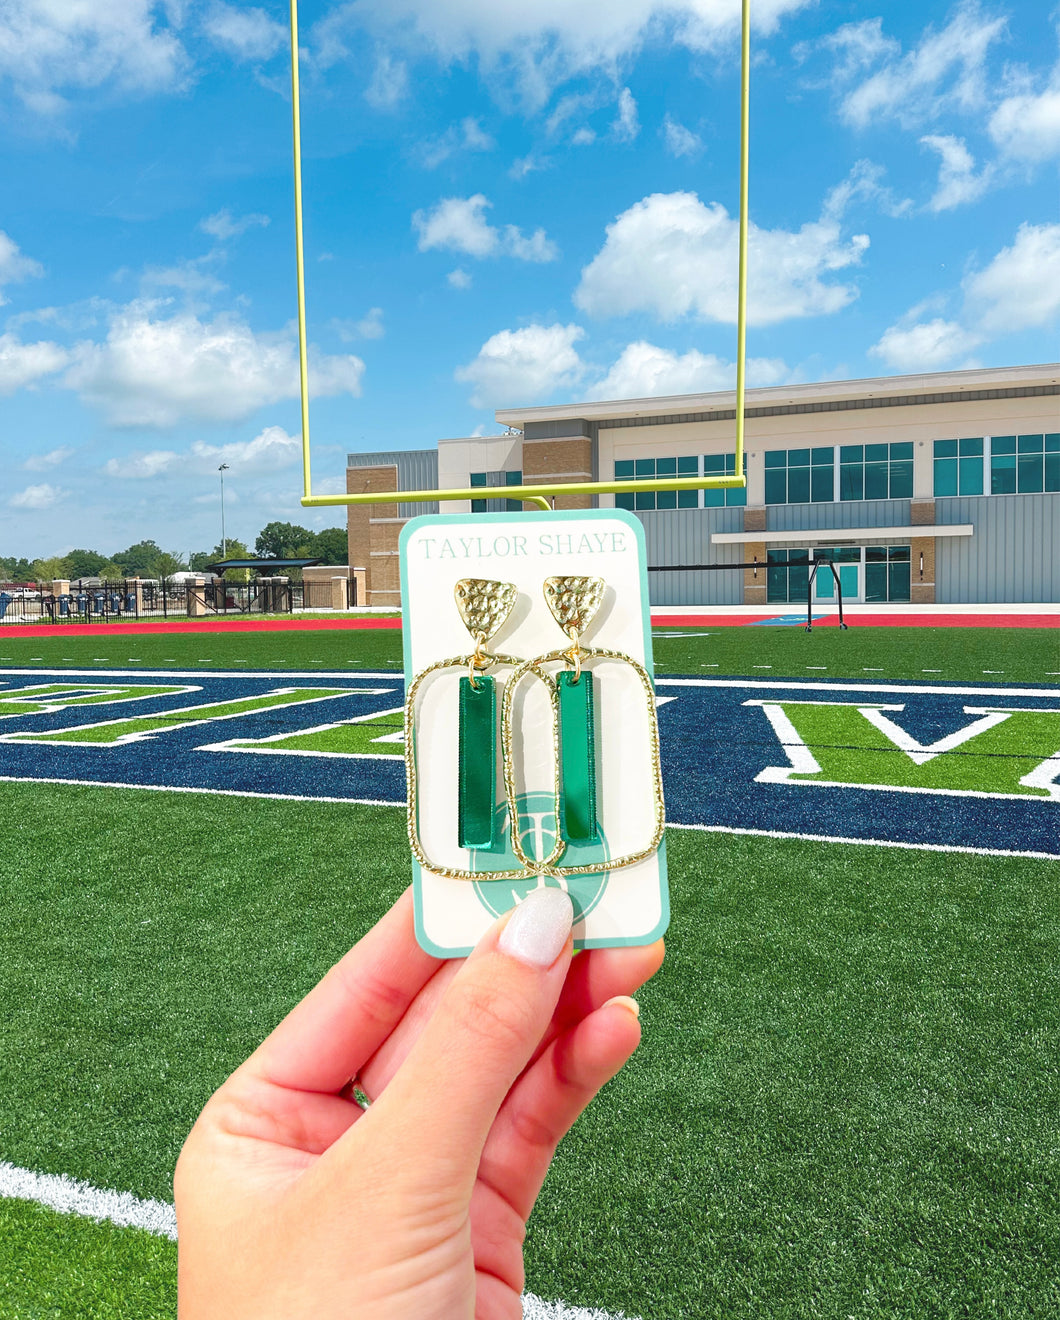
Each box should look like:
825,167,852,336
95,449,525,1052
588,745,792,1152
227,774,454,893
0,1160,632,1320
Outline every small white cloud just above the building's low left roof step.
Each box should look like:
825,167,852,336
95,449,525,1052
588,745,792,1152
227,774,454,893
454,325,585,408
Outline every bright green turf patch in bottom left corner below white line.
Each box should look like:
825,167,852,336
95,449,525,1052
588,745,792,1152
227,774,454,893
0,1201,177,1320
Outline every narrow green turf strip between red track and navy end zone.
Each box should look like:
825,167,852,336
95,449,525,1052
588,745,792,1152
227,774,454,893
0,624,1060,684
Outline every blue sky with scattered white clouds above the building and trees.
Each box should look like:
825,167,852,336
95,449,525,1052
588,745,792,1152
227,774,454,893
0,0,1060,558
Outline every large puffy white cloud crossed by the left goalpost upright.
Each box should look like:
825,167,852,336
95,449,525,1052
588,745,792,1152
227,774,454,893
63,301,364,426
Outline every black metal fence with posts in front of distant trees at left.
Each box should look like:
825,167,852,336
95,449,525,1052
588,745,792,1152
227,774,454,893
0,578,327,626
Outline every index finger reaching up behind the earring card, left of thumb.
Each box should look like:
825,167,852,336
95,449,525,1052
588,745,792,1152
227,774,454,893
244,888,441,1093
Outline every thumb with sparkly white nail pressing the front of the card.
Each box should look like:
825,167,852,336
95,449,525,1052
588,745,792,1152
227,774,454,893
366,888,574,1196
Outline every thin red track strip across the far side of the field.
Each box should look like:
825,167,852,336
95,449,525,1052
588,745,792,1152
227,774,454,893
4,610,1060,638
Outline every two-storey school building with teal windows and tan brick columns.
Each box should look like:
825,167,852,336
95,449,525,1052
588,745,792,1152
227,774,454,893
346,363,1060,605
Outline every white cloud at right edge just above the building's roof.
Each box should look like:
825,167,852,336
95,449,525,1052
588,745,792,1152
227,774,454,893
869,224,1060,370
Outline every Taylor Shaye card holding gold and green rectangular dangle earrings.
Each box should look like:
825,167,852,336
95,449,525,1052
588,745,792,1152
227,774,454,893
399,510,669,957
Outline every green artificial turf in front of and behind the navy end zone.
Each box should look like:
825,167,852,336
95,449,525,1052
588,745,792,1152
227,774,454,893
0,628,1060,1320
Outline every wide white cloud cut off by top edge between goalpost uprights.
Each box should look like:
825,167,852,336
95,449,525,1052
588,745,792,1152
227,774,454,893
343,0,807,106
